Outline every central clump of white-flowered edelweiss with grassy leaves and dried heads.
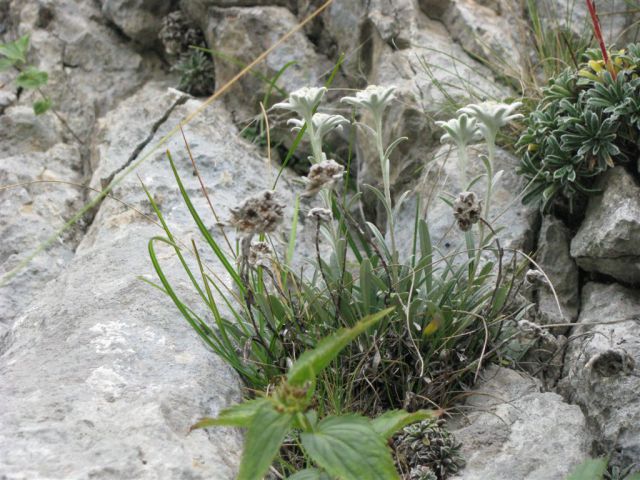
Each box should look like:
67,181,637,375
148,86,523,479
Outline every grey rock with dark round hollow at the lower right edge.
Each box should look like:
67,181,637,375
561,283,640,465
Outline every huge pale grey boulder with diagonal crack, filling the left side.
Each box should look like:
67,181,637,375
0,80,310,480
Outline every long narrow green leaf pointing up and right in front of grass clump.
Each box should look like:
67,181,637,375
287,308,394,385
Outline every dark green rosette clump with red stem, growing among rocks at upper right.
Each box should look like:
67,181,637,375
516,1,640,210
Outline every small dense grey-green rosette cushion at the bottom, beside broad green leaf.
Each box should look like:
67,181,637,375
394,419,465,480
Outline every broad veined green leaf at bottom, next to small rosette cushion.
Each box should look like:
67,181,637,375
300,415,400,480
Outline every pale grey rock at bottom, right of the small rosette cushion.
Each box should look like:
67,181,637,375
452,367,591,480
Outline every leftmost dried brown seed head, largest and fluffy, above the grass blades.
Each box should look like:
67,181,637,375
230,190,284,235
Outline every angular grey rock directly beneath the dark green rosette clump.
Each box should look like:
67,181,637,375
571,167,640,283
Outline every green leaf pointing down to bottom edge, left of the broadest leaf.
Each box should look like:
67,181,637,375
237,404,293,480
